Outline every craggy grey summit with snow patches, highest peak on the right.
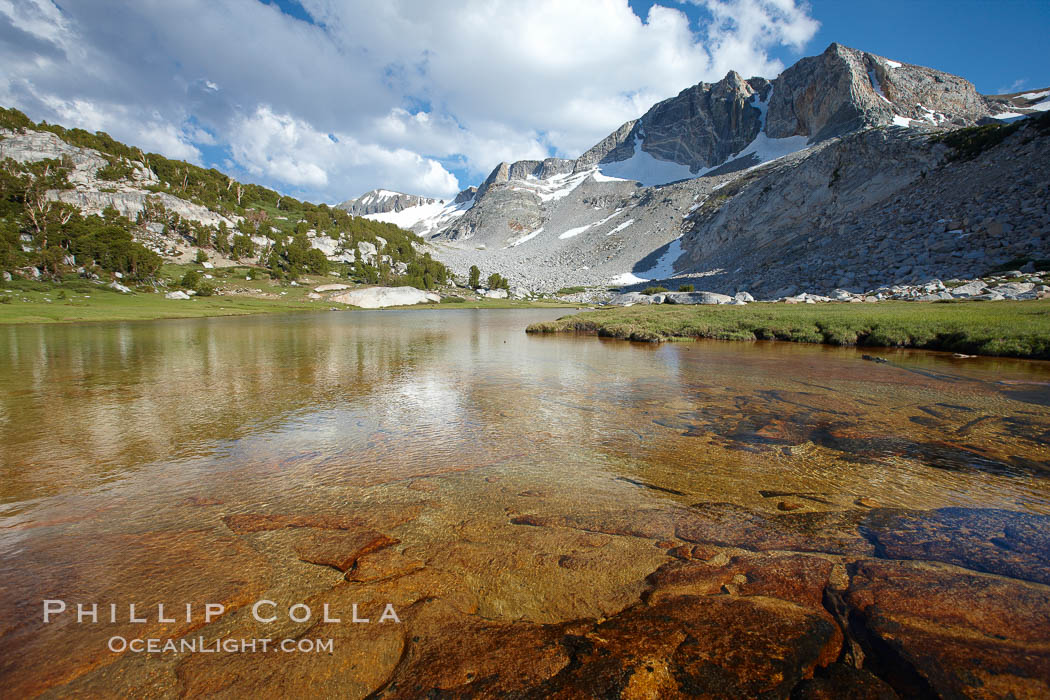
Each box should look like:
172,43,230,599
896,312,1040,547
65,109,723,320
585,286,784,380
592,44,999,185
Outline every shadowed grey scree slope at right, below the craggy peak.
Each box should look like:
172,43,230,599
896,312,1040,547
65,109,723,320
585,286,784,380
674,115,1050,297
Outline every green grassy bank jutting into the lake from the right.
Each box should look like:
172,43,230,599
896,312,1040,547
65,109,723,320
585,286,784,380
526,299,1050,360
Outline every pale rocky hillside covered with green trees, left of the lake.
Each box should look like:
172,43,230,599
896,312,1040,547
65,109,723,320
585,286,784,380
0,109,447,289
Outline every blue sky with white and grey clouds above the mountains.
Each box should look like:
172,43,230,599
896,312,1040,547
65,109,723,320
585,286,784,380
0,0,1050,203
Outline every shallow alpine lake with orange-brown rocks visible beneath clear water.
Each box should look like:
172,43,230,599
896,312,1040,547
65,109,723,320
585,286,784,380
0,310,1050,698
